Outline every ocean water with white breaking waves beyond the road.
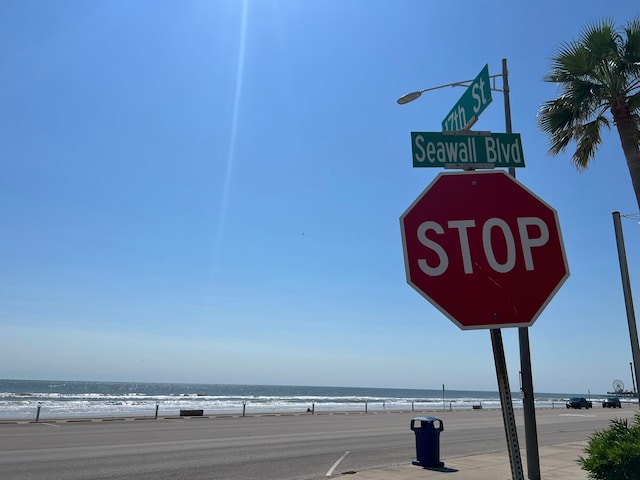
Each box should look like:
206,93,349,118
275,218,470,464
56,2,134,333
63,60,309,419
0,380,602,420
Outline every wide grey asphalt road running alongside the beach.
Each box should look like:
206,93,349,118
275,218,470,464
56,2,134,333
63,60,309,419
0,406,637,480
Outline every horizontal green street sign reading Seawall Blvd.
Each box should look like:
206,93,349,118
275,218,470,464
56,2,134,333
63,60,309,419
411,132,524,168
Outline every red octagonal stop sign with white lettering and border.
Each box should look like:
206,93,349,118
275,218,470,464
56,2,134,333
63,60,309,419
400,171,569,329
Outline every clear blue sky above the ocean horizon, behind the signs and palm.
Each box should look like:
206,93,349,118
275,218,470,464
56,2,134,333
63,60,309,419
0,0,640,393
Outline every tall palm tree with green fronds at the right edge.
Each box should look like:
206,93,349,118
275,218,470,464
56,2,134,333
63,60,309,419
538,19,640,208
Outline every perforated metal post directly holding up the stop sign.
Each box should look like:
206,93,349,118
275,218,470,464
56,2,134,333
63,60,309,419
490,328,525,480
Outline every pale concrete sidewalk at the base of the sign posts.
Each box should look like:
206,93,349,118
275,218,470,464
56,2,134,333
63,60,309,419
342,441,587,480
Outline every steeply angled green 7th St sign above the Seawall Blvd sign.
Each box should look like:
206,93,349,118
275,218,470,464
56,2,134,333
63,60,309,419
442,65,492,131
